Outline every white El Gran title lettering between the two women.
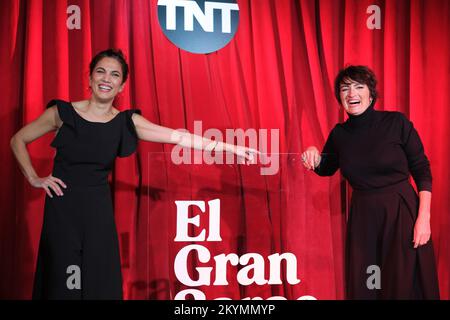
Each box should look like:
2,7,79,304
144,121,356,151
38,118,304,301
174,199,315,300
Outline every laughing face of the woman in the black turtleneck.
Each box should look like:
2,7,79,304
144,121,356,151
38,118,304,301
339,79,372,116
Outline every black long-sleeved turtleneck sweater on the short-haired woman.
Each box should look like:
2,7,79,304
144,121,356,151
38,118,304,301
315,106,431,191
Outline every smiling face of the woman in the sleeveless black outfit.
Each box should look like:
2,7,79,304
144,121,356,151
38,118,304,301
89,57,125,102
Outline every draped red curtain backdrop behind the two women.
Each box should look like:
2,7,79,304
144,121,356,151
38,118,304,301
0,0,450,299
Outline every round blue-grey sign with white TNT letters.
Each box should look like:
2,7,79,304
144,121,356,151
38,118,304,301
158,0,239,53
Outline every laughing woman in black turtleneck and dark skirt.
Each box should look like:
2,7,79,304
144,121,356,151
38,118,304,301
302,66,439,299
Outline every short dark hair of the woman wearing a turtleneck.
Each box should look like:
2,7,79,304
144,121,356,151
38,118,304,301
334,66,378,104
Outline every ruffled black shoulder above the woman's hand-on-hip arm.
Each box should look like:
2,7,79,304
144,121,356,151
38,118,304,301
46,99,77,148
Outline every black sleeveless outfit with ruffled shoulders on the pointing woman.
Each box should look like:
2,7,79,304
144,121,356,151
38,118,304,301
33,100,140,299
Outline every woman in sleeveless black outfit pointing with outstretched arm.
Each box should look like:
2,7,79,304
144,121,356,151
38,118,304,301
11,49,257,299
